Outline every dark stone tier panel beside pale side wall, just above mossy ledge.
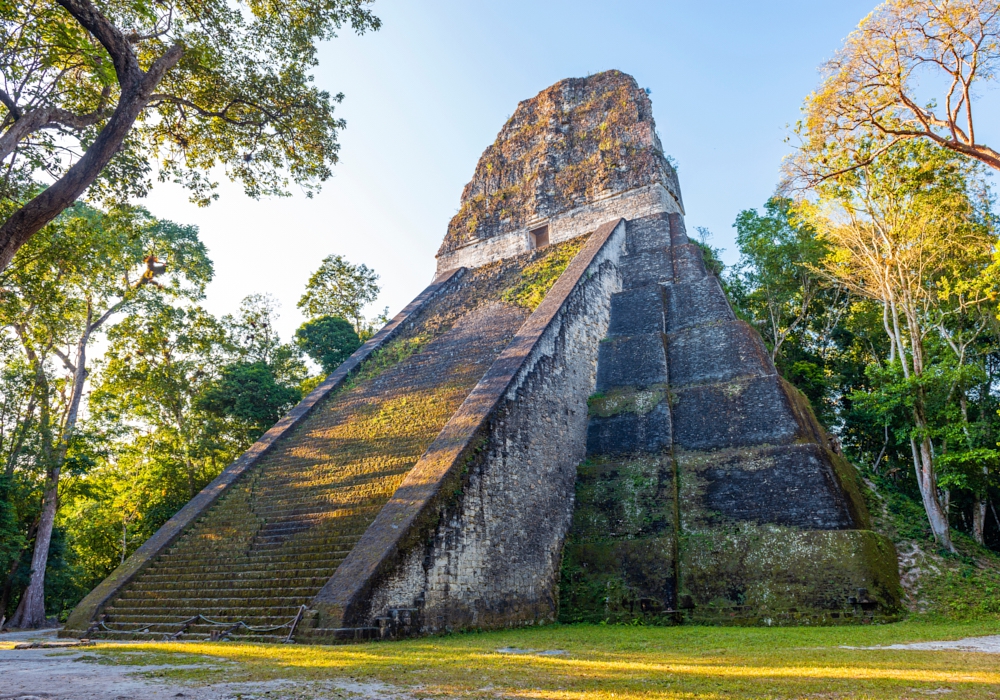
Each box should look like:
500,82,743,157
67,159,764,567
597,333,667,392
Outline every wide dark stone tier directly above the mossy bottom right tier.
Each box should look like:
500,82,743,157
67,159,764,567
676,444,864,530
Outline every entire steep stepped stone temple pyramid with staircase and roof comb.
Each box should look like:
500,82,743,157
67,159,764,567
62,71,900,643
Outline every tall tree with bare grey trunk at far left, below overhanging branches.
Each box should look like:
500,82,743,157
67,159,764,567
0,205,211,627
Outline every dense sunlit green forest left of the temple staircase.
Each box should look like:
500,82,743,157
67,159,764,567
0,205,378,626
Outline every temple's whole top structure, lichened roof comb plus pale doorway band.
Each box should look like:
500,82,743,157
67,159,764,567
438,70,684,270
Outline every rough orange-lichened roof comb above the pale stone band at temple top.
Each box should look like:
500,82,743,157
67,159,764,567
438,70,680,255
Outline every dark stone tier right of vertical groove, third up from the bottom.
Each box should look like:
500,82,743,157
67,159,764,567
670,375,811,450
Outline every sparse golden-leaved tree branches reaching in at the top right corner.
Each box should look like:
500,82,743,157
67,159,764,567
789,0,1000,183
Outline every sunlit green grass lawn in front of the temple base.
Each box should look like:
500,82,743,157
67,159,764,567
50,621,1000,700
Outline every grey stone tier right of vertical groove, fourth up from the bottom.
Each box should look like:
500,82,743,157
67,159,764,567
667,321,775,388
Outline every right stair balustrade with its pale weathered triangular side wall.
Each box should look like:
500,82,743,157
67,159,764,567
315,222,625,636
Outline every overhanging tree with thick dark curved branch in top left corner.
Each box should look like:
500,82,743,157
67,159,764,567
0,0,380,270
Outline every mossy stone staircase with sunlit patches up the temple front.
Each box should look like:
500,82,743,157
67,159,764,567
88,266,537,642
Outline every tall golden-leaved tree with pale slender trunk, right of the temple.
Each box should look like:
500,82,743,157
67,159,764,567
799,142,995,549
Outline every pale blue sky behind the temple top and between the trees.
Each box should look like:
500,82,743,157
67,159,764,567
141,0,996,338
